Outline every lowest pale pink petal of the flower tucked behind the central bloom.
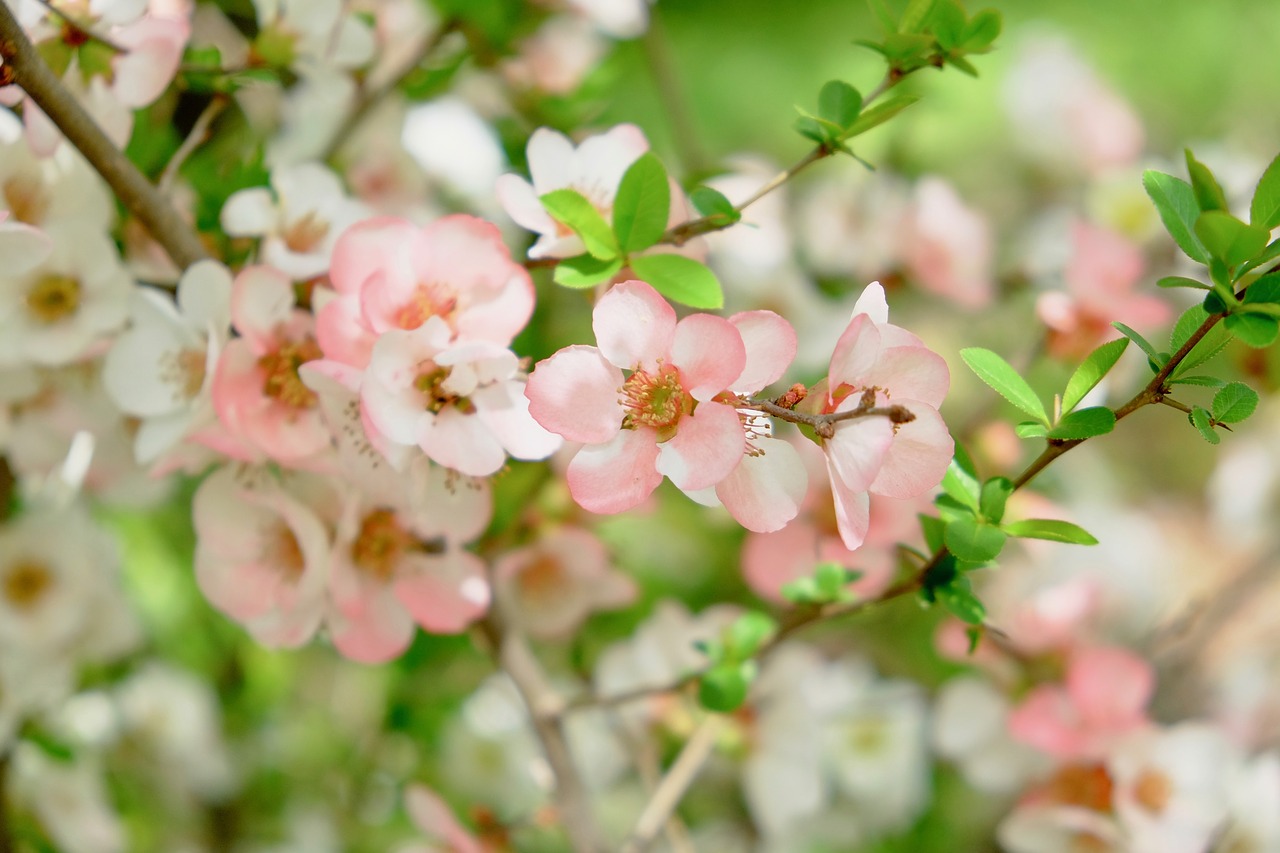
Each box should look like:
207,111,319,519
716,438,809,533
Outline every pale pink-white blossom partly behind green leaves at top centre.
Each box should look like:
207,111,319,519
497,124,649,257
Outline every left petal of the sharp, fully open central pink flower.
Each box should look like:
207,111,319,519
525,346,623,444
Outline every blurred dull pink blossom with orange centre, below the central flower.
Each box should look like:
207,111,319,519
493,528,636,637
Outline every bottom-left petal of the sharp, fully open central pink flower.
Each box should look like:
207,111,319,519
567,429,662,514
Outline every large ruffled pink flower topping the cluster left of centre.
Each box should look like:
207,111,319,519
316,215,534,368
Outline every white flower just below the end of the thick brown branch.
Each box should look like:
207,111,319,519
102,260,232,464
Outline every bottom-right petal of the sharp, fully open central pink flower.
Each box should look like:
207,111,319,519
658,399,746,492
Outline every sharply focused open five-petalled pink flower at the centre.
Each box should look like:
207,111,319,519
525,280,748,512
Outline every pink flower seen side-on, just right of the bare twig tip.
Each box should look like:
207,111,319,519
805,282,955,549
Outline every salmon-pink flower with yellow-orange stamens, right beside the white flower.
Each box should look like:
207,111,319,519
200,266,330,464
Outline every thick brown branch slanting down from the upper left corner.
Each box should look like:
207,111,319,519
0,3,209,269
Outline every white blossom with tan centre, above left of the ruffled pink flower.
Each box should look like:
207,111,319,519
221,163,369,279
